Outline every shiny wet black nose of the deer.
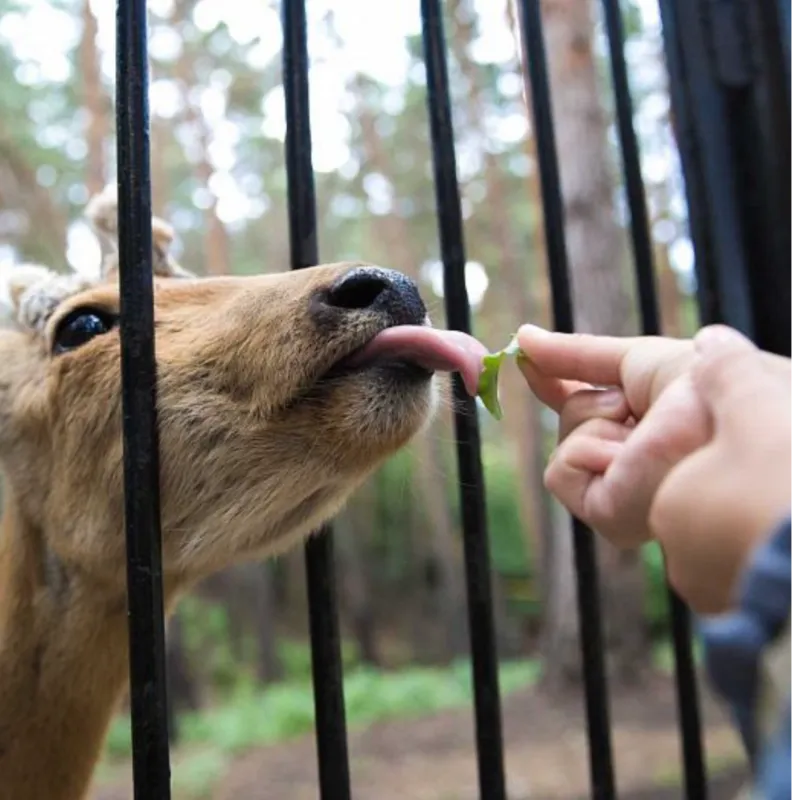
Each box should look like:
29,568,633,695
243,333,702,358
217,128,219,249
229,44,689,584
324,267,426,325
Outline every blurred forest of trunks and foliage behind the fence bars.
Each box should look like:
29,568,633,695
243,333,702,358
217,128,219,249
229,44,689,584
0,0,724,796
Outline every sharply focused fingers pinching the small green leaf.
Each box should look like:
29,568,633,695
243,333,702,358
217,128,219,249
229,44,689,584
518,326,792,547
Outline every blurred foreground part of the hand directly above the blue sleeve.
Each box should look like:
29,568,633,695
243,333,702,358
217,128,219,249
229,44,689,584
649,327,792,614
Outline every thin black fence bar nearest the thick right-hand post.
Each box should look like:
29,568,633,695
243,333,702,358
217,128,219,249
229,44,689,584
602,0,707,800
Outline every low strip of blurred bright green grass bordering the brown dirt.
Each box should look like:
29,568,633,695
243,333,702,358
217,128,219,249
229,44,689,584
97,643,704,800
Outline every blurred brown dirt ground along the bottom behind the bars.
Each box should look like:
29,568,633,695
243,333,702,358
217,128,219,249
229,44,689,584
92,677,745,800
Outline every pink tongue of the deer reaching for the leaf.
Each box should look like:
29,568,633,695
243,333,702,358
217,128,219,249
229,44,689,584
348,325,488,397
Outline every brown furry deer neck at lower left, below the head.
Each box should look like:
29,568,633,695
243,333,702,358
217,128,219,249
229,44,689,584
0,487,128,800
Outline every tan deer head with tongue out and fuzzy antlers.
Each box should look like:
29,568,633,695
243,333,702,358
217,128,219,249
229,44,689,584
0,188,484,598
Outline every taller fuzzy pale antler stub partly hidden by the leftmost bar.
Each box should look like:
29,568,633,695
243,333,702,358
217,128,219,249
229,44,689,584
85,184,194,279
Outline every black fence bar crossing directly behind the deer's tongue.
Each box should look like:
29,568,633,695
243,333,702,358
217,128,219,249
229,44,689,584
421,0,506,800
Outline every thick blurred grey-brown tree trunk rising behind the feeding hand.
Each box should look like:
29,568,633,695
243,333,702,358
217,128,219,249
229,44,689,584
543,0,649,681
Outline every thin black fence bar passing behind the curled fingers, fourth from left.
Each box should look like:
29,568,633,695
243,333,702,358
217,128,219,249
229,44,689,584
519,0,616,800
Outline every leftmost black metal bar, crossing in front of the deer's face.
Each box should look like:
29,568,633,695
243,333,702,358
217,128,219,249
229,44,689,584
116,0,170,800
